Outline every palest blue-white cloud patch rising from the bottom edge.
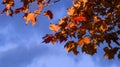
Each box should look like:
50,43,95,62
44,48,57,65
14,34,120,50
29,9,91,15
27,49,100,67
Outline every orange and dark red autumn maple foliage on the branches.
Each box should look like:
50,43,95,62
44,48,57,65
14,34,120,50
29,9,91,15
1,0,120,60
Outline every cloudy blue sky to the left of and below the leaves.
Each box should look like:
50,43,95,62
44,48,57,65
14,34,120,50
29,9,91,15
0,0,120,67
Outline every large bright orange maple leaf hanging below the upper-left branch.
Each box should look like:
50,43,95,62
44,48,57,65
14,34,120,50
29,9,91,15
23,12,36,26
